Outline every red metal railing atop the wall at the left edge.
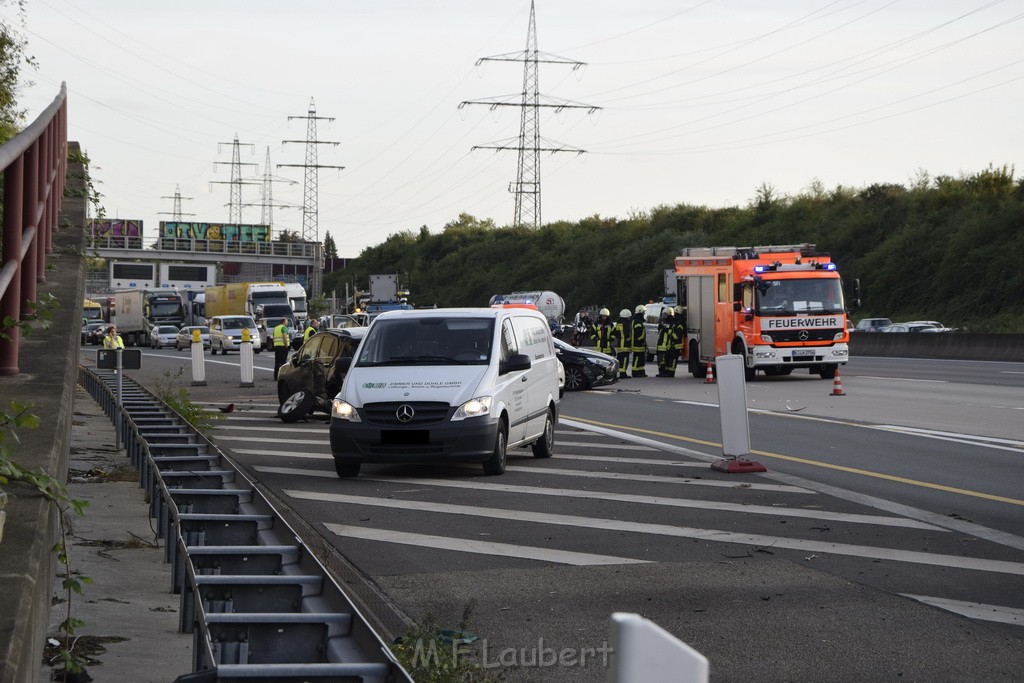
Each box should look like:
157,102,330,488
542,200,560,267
0,83,68,375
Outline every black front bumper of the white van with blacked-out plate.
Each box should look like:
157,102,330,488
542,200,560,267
331,418,498,463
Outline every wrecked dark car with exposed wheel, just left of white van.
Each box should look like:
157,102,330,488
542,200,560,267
278,328,367,422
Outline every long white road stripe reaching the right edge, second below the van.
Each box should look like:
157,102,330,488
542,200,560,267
283,489,1024,575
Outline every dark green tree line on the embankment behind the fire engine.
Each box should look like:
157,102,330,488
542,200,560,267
324,166,1024,332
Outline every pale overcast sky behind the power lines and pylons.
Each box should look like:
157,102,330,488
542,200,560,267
14,0,1024,257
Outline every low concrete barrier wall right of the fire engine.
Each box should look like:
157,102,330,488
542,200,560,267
850,332,1024,362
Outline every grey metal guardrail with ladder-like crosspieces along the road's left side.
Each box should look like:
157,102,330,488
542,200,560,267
79,368,412,683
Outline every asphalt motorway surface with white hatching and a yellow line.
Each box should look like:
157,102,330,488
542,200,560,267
83,350,1024,681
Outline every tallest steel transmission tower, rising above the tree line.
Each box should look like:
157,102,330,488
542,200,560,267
459,1,600,227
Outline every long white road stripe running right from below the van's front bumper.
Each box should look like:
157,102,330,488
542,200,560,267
354,476,946,531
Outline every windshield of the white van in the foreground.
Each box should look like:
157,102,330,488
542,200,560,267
355,317,495,368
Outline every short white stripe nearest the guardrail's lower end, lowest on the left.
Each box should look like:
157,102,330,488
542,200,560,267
324,522,650,566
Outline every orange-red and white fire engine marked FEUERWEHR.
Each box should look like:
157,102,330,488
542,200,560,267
675,244,850,380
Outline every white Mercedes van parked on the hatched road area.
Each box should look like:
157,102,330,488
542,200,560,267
331,306,559,477
